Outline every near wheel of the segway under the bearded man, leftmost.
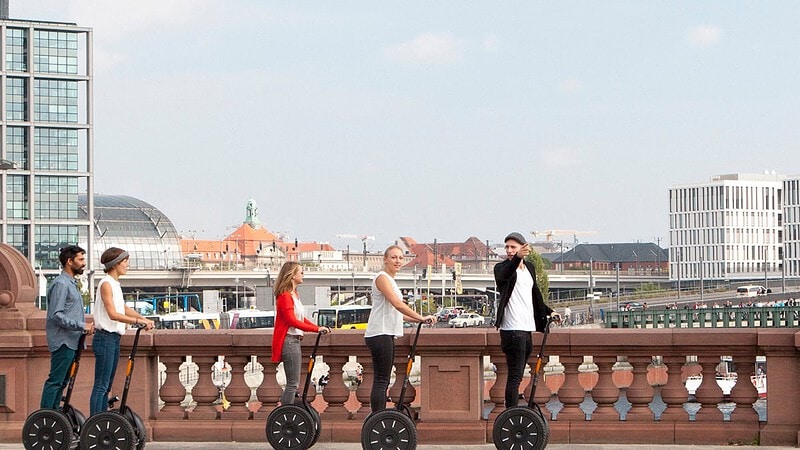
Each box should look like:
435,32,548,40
22,409,74,450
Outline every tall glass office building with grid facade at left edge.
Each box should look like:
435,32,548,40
0,18,96,273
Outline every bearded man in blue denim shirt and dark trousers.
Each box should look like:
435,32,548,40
40,245,94,409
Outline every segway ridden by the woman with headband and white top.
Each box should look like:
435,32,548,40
80,324,147,450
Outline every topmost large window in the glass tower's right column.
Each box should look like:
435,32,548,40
33,30,78,75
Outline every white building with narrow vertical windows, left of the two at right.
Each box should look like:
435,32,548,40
669,173,780,281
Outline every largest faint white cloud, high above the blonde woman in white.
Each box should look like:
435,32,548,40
385,33,462,64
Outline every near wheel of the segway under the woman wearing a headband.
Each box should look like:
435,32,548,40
81,411,139,450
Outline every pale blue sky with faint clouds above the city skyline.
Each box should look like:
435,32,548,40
10,0,800,250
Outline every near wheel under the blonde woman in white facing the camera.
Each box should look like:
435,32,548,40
361,409,417,450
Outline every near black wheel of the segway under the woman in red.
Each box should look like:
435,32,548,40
266,405,317,450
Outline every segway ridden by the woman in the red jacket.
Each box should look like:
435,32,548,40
266,333,323,450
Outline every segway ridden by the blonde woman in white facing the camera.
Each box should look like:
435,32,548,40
361,320,428,450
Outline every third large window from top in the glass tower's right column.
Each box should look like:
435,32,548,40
33,128,78,172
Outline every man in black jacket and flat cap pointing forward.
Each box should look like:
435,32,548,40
494,232,560,408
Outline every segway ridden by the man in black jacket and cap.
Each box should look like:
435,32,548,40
492,318,554,450
